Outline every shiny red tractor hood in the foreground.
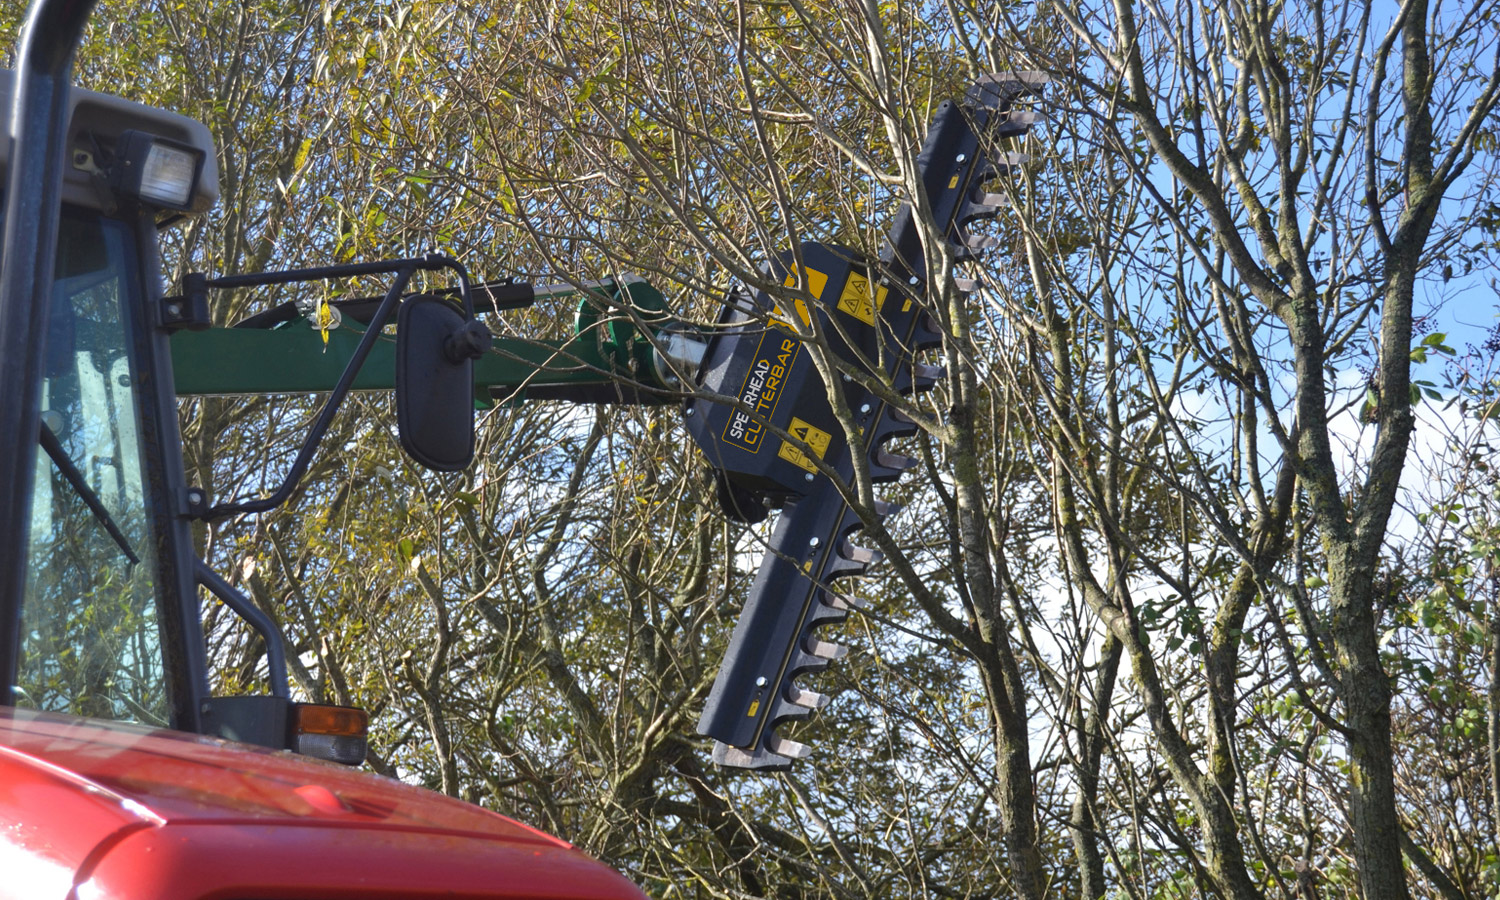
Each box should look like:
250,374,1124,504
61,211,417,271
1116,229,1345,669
0,708,641,900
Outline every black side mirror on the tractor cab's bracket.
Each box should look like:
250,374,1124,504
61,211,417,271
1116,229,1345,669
396,294,491,473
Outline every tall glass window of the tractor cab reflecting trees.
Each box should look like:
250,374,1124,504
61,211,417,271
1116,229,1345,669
15,212,168,726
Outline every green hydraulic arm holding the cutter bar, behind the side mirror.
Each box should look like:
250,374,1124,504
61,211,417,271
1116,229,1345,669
171,276,675,405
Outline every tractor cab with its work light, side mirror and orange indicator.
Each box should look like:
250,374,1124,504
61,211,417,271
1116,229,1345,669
0,72,488,765
